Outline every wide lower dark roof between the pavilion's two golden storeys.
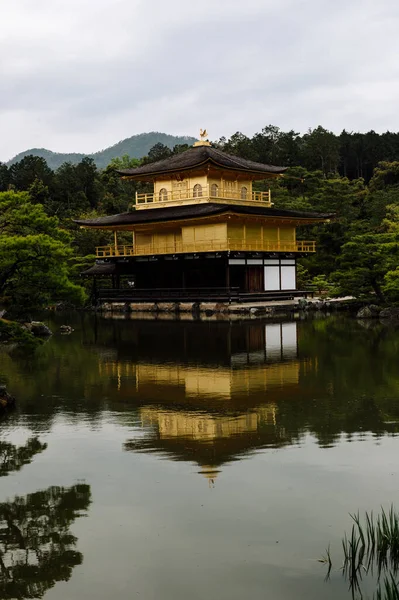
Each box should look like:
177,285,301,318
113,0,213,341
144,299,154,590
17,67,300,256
75,202,334,227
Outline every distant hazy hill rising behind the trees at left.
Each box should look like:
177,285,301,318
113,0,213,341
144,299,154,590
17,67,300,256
7,131,196,170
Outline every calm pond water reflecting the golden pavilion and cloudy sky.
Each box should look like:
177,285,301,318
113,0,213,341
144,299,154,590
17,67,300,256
0,315,399,600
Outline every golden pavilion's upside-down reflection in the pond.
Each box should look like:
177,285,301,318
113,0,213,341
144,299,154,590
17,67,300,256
100,322,306,481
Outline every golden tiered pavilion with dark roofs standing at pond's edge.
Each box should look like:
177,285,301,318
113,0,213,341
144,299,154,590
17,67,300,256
77,133,331,300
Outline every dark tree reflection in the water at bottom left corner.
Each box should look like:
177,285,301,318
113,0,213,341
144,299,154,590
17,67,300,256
0,484,91,599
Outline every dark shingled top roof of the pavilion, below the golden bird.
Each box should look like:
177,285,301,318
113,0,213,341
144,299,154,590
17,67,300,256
117,146,288,179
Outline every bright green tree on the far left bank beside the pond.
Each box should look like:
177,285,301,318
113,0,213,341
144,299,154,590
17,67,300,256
0,191,84,311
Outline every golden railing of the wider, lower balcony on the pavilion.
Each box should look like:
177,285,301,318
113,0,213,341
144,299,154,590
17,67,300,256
96,239,316,258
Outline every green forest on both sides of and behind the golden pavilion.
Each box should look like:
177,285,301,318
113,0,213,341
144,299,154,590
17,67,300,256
0,126,399,309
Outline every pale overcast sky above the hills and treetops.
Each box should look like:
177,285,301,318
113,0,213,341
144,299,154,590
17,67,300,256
0,0,399,161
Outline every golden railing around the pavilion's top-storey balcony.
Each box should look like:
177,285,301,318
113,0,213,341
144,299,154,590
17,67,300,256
136,185,272,208
